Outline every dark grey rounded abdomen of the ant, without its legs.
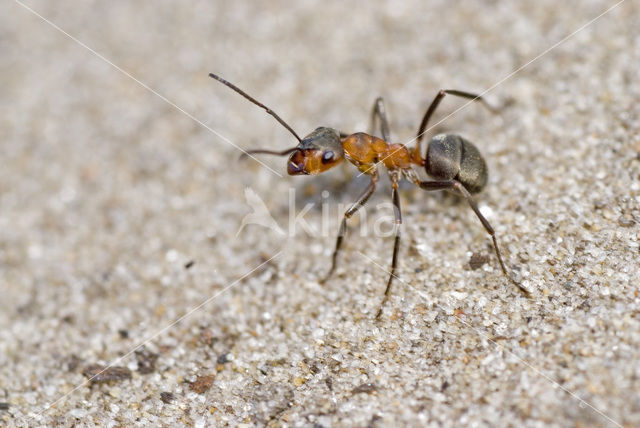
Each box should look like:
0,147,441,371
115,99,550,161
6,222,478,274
425,134,489,193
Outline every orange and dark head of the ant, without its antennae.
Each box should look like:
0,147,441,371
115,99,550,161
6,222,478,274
287,127,344,175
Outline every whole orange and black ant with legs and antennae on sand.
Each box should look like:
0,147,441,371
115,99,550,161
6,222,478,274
209,73,529,318
